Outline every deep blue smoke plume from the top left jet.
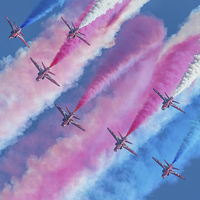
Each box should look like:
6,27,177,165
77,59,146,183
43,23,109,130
21,0,65,28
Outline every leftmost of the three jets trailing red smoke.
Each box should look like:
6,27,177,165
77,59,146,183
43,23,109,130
30,58,60,86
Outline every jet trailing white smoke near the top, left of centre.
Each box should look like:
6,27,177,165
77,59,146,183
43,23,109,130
61,17,90,46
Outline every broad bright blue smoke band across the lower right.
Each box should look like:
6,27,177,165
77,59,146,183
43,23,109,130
70,83,200,200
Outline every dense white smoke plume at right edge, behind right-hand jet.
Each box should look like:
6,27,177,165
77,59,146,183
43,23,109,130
173,54,200,96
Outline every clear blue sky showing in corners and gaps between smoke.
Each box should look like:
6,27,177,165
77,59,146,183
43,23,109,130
0,0,200,200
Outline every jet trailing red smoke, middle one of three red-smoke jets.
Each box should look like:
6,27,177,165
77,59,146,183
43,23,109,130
55,103,85,131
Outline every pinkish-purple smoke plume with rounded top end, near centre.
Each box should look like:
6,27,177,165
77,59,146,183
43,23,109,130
75,16,165,111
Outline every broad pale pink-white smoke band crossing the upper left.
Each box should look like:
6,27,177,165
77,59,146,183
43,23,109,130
0,0,147,150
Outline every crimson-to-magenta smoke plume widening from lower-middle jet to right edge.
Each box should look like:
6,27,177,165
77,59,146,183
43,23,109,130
126,35,200,136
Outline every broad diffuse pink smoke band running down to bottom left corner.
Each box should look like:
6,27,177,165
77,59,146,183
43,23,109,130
0,45,163,200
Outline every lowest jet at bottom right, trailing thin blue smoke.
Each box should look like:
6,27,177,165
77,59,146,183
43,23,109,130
152,157,186,180
